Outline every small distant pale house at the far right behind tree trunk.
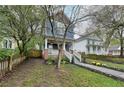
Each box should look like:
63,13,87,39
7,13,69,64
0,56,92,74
108,45,121,55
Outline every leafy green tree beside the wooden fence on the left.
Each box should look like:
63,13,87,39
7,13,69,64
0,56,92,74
0,6,43,55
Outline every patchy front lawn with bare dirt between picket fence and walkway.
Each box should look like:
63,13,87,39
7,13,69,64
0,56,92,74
0,60,124,87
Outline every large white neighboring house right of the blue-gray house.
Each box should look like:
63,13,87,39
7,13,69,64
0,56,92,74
73,34,106,55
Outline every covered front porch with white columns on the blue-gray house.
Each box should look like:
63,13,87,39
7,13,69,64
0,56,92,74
43,38,72,59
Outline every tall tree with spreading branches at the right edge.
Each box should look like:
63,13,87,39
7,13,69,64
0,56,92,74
93,6,124,57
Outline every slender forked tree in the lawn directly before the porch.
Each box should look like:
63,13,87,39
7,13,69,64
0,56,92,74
43,6,90,68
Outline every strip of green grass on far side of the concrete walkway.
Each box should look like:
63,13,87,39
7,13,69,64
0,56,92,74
86,59,124,70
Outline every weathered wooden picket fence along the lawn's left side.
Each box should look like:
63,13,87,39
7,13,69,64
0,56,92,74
0,57,26,78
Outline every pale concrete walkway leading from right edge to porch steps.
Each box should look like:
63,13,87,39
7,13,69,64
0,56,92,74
75,58,124,81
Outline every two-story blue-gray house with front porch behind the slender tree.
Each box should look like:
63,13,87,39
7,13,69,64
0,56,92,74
43,12,74,58
